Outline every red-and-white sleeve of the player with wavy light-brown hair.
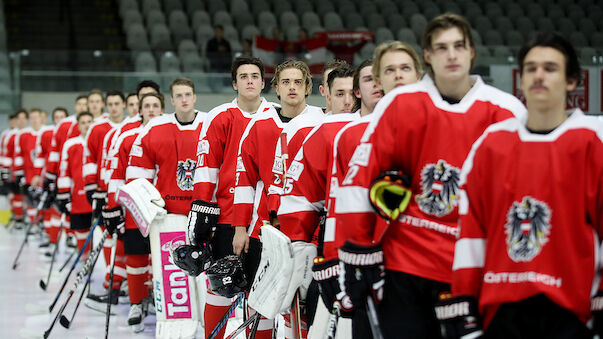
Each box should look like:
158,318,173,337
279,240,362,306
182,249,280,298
232,125,260,227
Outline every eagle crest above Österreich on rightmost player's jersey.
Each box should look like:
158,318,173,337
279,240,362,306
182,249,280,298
505,196,551,262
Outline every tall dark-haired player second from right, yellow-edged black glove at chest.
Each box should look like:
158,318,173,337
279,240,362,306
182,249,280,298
335,14,525,338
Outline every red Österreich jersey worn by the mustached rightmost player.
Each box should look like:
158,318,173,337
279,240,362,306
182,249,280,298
452,110,603,325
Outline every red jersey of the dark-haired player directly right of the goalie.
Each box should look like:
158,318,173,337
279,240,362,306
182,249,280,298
194,98,273,225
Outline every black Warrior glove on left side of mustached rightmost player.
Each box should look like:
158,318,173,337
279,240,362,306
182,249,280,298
435,296,483,339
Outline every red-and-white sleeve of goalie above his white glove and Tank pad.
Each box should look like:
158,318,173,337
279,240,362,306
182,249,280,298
126,126,156,183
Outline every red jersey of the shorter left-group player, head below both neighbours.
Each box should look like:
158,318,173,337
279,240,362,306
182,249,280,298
57,136,92,214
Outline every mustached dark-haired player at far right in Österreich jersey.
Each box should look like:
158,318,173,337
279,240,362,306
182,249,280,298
444,33,603,338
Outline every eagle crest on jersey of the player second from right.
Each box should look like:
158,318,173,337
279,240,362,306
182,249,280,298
415,160,460,217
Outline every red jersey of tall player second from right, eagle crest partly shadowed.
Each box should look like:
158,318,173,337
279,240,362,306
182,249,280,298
335,76,525,282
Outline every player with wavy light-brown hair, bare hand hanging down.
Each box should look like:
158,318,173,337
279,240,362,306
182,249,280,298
232,60,320,338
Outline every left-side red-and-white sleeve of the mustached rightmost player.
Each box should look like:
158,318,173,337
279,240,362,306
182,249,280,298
451,137,487,297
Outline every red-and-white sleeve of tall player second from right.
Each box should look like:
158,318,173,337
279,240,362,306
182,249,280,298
335,95,426,244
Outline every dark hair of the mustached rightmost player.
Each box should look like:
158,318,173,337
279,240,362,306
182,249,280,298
517,32,582,82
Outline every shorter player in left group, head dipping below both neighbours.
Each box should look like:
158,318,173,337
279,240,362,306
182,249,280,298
55,112,94,253
